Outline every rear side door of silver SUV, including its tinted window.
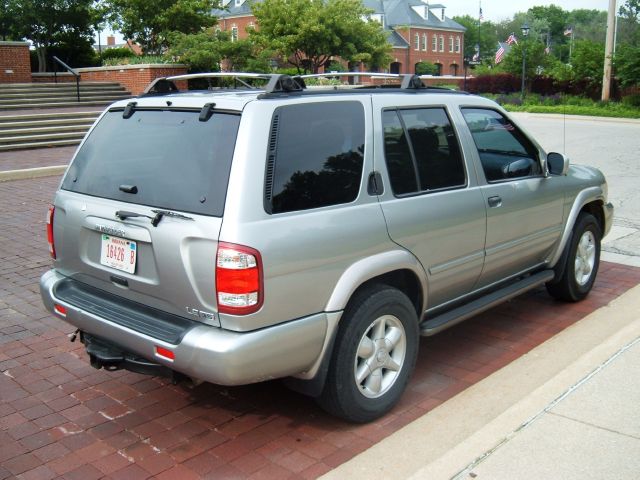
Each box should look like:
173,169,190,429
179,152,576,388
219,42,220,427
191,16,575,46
374,97,486,308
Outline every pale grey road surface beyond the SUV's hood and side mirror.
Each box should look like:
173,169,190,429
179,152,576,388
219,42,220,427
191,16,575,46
512,113,640,266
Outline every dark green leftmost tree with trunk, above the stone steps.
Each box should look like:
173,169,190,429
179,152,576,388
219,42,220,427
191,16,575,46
5,0,93,72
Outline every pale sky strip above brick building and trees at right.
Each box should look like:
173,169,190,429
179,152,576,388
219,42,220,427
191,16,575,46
448,0,621,22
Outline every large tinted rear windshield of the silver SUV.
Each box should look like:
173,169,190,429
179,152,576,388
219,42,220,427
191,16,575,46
62,110,240,216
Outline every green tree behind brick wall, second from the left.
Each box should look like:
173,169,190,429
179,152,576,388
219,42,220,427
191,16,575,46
105,0,219,54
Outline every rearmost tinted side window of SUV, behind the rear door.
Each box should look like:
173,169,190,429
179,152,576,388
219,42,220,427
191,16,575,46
265,102,364,213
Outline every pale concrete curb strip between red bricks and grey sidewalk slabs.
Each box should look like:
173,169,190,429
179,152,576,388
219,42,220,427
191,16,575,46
321,286,640,480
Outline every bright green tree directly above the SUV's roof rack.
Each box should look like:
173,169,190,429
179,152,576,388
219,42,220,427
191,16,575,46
250,0,391,73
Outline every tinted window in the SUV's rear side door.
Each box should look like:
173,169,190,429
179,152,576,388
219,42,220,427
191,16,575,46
382,108,466,195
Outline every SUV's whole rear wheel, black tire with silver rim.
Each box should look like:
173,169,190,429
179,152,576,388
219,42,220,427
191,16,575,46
317,285,419,423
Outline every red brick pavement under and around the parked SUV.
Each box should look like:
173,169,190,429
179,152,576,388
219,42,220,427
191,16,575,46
0,177,640,479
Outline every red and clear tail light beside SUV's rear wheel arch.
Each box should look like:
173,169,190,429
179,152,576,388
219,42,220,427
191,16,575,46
216,242,264,315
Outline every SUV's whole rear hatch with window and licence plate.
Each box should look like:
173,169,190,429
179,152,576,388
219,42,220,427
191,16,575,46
54,107,240,325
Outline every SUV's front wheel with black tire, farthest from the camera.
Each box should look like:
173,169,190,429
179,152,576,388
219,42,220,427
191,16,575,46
546,213,602,302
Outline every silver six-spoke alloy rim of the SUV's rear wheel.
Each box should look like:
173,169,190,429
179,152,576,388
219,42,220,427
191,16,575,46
353,315,407,398
